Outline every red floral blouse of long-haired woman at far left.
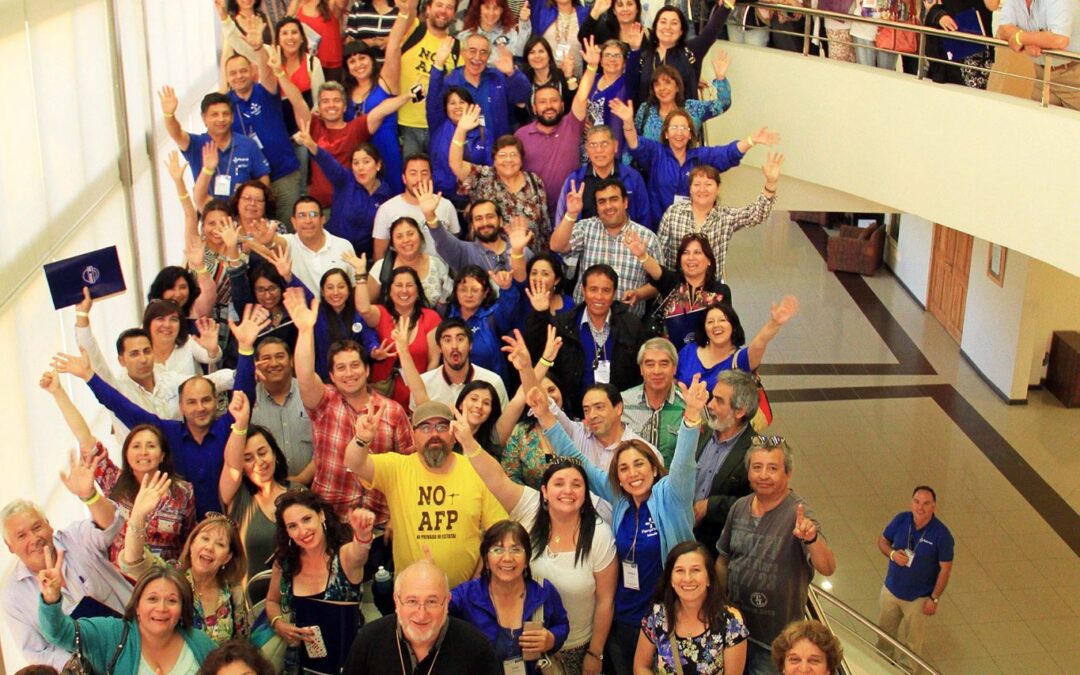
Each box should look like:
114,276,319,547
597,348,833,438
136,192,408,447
94,442,195,567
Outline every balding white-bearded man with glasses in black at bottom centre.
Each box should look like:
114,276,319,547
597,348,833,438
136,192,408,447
341,561,503,675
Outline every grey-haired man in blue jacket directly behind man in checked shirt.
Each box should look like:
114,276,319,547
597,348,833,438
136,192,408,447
555,124,656,229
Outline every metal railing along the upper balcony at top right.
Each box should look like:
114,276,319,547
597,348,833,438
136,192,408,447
739,2,1080,108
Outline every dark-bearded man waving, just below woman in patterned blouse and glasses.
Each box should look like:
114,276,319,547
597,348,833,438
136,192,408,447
420,185,532,275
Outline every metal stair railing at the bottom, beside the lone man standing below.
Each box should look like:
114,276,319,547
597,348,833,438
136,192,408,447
807,584,941,675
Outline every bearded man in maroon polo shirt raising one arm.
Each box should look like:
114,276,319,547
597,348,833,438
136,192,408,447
514,40,599,213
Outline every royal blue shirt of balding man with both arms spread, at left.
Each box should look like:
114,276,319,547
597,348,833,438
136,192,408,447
87,354,255,519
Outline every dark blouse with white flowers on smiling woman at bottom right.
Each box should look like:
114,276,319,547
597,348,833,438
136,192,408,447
642,604,750,675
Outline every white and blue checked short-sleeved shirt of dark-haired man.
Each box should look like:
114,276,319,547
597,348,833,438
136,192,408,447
570,218,660,316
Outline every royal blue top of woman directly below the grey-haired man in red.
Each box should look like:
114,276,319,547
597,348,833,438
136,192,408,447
312,150,401,258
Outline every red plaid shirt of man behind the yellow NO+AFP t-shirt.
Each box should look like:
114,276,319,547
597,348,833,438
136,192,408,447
308,384,414,523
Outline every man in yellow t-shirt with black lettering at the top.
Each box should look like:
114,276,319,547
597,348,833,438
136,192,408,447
387,0,458,158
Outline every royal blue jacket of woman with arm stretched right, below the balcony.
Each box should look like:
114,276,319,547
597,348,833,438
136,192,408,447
630,137,743,225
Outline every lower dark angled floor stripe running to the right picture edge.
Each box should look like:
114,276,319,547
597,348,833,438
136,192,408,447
769,384,1080,555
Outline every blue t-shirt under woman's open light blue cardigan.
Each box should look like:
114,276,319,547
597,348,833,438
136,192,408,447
615,503,664,625
